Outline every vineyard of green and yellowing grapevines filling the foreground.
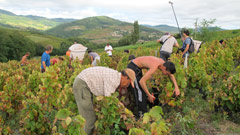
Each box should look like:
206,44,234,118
0,37,240,135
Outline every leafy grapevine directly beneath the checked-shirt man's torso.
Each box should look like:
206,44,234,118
94,94,135,135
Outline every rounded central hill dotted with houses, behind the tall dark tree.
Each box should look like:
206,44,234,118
46,16,163,43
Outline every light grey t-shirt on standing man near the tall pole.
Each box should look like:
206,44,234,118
159,35,177,53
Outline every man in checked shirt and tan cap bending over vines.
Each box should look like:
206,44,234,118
73,66,135,134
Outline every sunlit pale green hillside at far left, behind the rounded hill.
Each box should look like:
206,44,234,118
0,9,75,30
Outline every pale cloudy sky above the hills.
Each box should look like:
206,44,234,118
0,0,240,29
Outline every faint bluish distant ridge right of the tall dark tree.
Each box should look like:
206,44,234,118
143,24,179,33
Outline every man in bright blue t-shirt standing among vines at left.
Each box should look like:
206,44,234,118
41,45,53,73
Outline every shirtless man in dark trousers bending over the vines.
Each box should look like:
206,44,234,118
127,56,180,118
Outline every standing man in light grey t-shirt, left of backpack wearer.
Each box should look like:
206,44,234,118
157,32,179,61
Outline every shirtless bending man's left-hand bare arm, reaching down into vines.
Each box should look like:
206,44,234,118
139,68,157,103
